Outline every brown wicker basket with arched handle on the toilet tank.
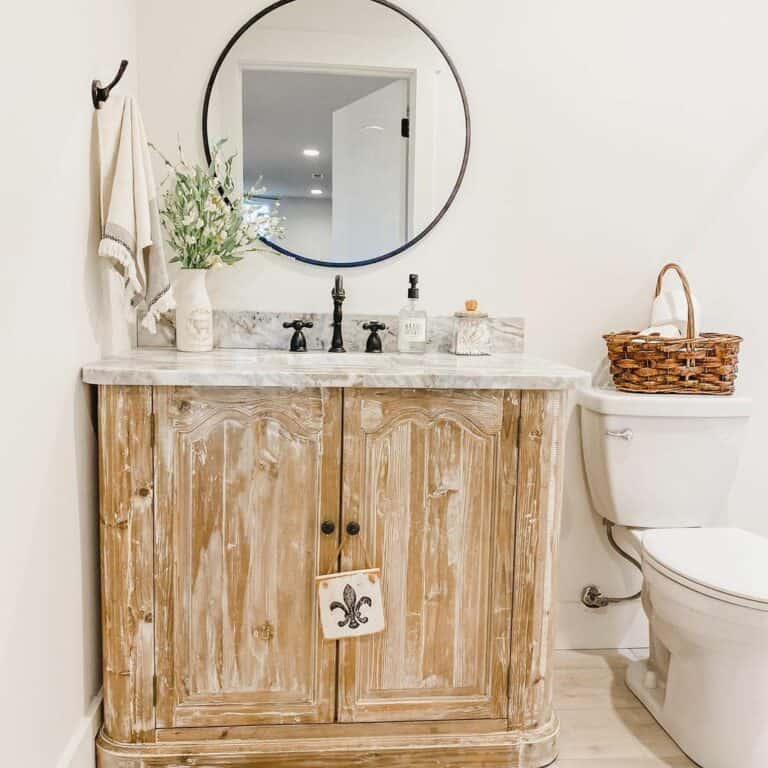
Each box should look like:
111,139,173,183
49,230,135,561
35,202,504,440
603,264,743,395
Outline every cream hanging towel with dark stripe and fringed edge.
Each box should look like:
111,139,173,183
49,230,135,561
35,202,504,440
97,97,176,333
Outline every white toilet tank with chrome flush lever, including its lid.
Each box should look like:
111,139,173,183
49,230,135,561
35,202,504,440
579,388,751,528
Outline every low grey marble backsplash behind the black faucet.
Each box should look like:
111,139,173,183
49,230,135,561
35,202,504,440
138,310,525,353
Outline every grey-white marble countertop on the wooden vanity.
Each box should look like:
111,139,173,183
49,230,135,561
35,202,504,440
83,349,589,389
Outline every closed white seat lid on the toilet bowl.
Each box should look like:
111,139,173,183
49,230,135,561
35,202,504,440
643,528,768,604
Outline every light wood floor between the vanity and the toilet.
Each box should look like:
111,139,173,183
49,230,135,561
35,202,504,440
553,651,695,768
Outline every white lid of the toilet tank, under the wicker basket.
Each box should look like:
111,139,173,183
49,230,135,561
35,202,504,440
577,387,752,419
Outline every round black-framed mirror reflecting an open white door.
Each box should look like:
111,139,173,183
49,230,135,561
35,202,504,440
203,0,470,267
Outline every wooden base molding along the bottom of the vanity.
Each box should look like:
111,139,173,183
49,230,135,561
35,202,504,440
96,719,559,768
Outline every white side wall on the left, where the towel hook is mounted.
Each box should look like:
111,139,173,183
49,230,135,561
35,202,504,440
0,0,136,768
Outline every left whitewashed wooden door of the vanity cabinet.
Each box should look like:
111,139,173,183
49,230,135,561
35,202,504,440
155,387,341,728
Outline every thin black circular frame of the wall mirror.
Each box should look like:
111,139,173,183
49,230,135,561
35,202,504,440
203,0,472,269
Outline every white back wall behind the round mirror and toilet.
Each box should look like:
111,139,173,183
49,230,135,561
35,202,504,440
139,0,768,646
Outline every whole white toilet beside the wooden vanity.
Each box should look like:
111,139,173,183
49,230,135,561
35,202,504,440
580,389,768,768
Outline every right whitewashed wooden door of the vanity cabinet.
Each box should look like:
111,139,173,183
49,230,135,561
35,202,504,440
339,390,519,722
